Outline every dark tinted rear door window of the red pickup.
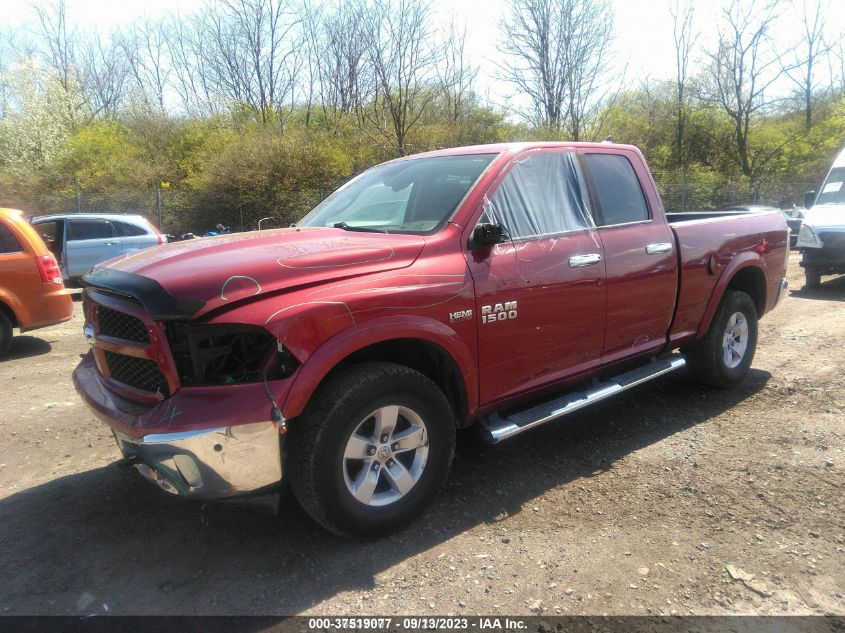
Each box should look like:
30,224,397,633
584,153,650,226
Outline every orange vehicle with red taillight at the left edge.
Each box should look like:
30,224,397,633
0,209,73,356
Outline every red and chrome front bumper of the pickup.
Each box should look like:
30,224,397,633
73,354,282,500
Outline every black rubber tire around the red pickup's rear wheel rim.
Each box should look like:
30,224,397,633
685,290,757,388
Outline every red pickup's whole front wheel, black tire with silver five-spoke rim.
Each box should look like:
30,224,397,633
286,363,455,536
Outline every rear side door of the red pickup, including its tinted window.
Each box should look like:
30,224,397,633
581,148,678,363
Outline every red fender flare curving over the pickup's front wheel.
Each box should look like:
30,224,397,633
282,315,478,419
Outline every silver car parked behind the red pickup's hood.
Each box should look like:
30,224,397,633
32,213,165,283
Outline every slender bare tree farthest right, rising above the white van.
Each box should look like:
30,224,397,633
784,0,830,130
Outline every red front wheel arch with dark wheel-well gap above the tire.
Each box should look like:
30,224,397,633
282,317,478,426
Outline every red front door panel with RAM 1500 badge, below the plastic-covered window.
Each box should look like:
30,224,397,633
470,232,605,405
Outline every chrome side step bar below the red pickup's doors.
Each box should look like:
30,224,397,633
482,354,687,444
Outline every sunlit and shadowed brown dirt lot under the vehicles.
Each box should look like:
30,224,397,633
0,256,845,615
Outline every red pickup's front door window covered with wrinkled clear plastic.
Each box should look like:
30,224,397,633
482,152,593,239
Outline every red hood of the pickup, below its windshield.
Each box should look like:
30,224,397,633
95,228,425,318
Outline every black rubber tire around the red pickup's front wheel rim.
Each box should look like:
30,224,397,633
285,363,455,537
